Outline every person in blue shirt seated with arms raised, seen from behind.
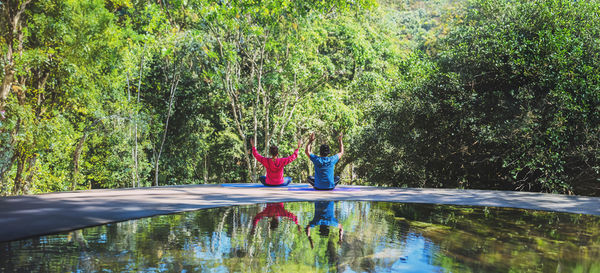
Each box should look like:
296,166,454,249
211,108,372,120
304,133,344,190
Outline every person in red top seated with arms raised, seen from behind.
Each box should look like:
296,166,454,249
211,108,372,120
250,139,302,187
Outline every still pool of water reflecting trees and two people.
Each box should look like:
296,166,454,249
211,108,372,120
0,201,600,272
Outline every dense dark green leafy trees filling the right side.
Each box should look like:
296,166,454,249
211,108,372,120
363,1,600,194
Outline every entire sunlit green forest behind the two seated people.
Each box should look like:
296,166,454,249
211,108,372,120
0,0,600,196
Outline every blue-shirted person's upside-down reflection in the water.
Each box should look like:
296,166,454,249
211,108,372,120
306,201,344,248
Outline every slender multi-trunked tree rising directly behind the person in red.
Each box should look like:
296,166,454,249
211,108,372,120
199,1,372,183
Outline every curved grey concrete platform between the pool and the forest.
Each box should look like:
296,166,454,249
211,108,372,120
0,185,600,242
